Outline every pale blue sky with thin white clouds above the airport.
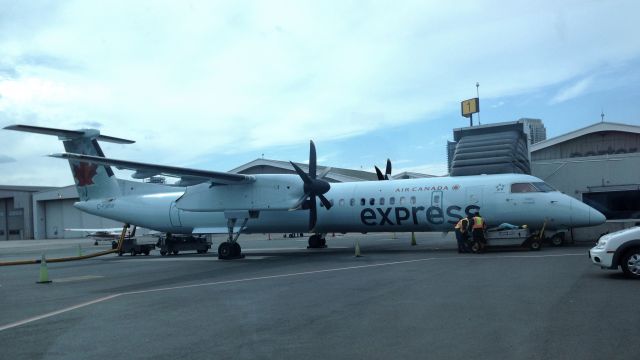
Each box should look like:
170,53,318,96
0,0,640,186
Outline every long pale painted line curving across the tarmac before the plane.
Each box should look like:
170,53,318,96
0,253,585,331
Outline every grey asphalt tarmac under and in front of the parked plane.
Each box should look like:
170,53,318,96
0,233,640,359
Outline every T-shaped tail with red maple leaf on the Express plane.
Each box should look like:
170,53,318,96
5,125,134,201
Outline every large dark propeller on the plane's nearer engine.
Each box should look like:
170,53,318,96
290,141,332,231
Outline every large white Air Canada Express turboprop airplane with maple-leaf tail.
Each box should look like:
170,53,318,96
5,125,606,259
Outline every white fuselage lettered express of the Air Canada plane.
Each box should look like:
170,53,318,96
75,174,605,234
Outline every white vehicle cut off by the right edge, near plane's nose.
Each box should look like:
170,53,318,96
589,226,640,279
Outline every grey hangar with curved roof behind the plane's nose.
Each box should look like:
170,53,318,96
530,121,640,239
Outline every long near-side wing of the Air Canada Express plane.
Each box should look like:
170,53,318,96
49,153,256,185
